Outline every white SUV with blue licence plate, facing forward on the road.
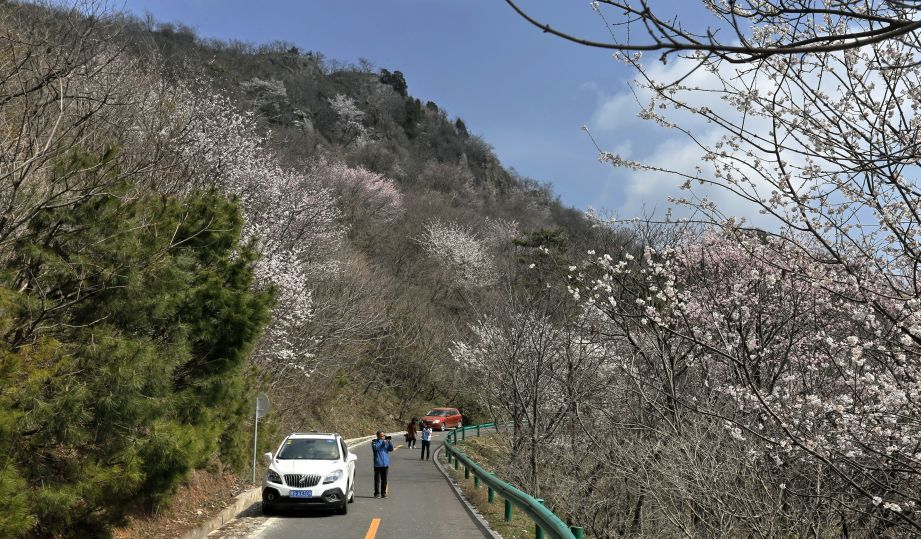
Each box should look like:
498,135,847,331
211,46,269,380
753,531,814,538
262,432,358,515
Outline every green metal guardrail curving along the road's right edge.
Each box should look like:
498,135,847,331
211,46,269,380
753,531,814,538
444,423,582,539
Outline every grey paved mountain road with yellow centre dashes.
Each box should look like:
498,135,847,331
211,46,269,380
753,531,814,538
209,433,484,539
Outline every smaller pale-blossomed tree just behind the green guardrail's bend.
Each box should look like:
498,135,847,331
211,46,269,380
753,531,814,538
451,293,610,495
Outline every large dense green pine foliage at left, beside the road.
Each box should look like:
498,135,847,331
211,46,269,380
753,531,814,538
0,151,271,537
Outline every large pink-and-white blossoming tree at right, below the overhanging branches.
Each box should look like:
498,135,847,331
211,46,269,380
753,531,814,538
571,229,921,530
